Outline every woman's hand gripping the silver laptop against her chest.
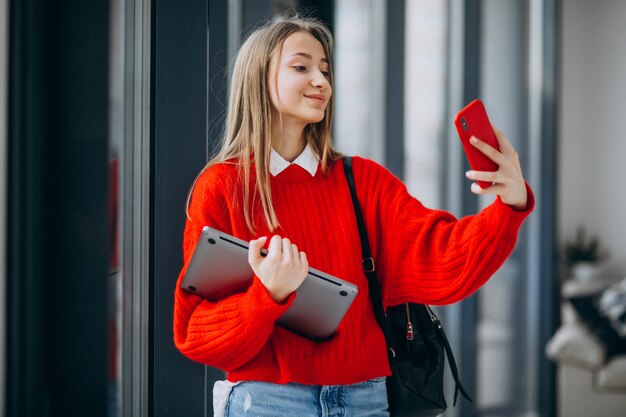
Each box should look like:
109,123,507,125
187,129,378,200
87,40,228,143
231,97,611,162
248,235,309,303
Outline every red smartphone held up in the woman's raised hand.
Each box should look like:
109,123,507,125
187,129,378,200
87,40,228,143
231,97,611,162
454,99,500,188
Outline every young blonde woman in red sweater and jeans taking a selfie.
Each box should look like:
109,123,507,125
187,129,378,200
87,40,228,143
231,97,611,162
174,14,533,416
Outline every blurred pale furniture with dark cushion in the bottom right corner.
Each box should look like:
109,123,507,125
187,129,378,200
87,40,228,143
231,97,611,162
546,279,626,417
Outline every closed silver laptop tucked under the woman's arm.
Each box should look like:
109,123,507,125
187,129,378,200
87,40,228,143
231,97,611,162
181,226,358,341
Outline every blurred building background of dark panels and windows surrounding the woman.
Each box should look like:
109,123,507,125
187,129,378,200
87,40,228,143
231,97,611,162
0,0,626,417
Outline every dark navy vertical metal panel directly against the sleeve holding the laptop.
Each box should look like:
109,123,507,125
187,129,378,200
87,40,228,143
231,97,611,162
149,0,213,417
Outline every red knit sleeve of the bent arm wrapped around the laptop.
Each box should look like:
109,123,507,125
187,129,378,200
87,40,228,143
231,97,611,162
174,164,294,371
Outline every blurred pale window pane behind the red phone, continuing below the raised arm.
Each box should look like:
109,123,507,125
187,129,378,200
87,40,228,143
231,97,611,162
476,0,537,416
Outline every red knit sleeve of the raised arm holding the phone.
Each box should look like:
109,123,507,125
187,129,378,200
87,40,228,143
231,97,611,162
354,158,534,306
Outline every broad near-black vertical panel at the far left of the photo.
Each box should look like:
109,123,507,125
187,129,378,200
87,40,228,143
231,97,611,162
6,0,109,417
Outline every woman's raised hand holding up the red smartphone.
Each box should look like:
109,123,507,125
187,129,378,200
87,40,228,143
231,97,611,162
465,125,528,210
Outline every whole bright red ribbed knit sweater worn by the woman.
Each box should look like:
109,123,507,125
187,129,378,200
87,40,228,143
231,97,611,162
174,157,534,385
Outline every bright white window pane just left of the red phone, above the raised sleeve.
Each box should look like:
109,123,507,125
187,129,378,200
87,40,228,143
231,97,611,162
404,0,448,208
